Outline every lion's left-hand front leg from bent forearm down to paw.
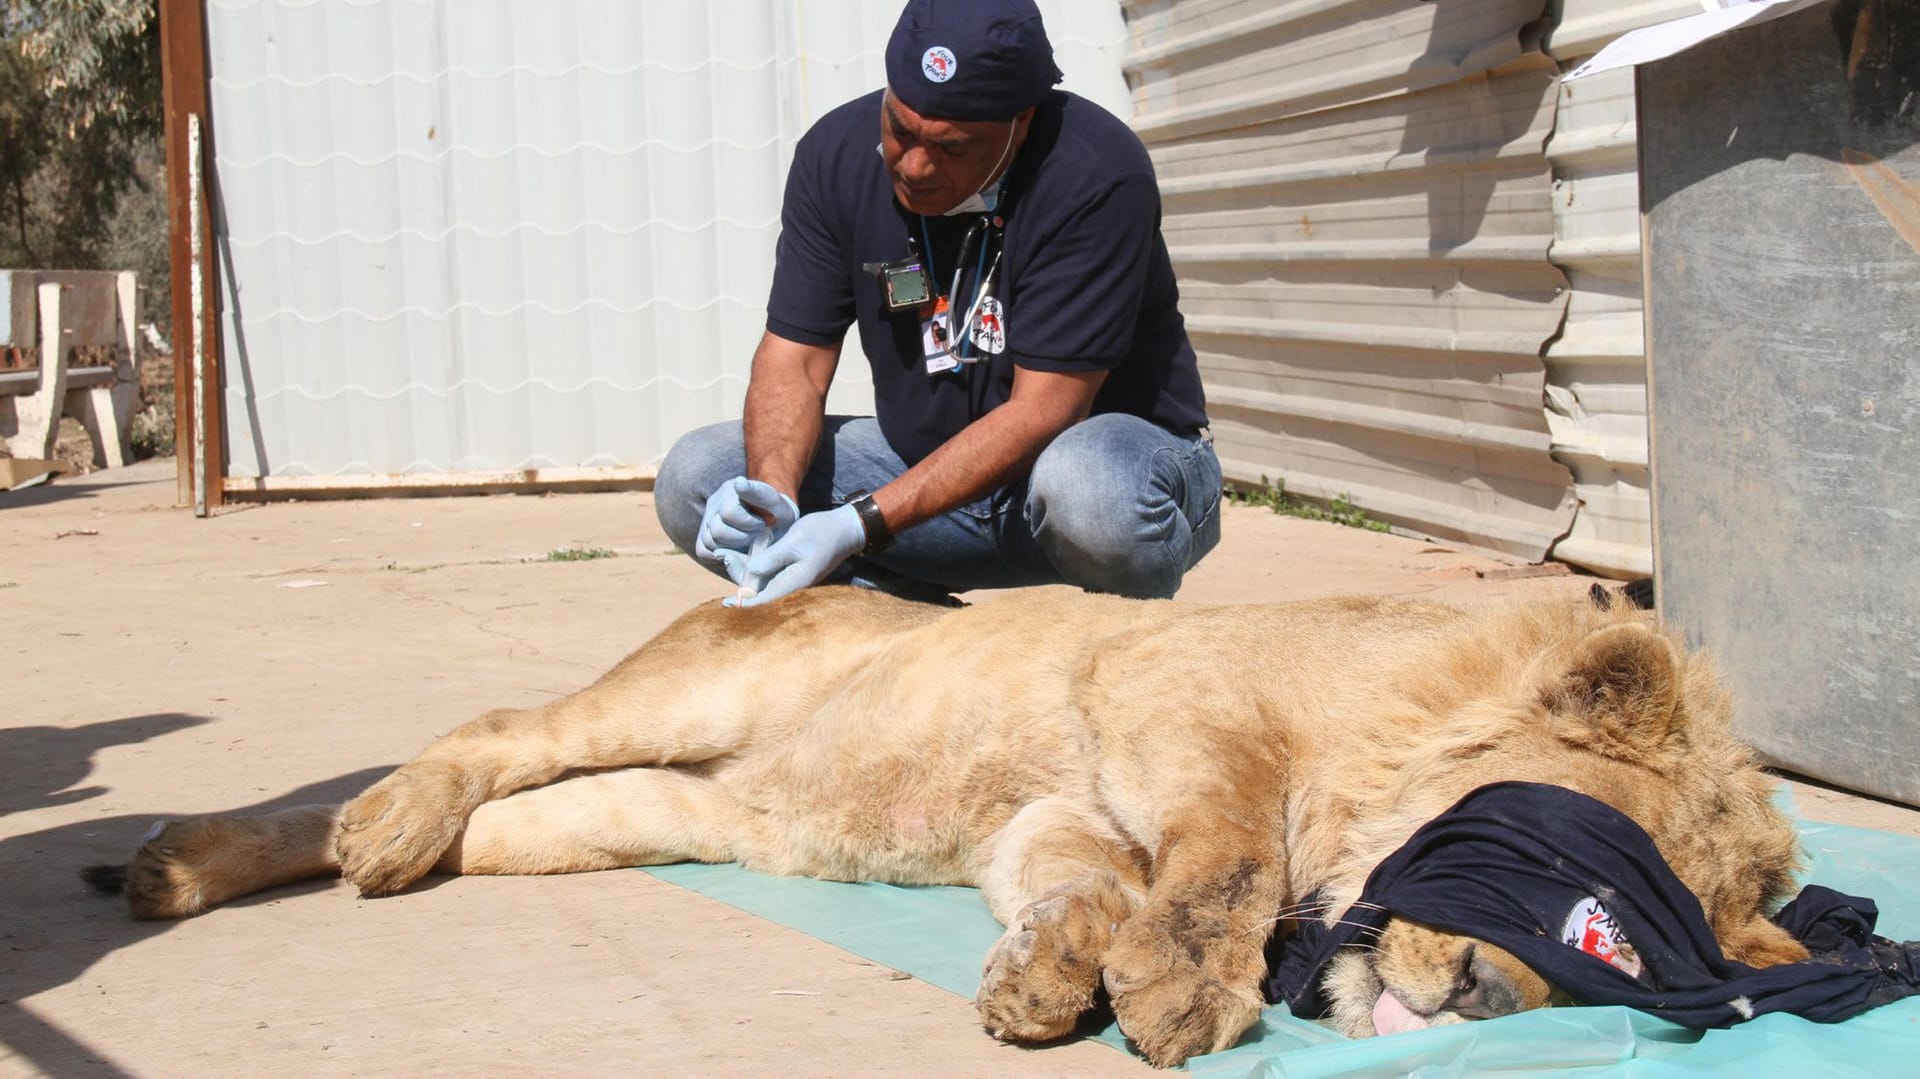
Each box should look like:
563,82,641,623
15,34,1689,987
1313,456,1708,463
973,797,1146,1043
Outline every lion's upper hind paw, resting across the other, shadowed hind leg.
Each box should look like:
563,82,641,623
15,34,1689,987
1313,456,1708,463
334,764,480,895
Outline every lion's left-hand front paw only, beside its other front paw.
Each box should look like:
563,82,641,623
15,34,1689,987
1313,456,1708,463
973,895,1112,1043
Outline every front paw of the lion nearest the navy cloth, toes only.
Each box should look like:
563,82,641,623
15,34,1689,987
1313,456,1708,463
1102,945,1263,1067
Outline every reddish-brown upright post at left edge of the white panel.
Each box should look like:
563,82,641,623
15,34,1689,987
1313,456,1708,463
159,0,227,507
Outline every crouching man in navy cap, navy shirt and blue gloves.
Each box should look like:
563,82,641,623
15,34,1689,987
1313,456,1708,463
655,0,1221,607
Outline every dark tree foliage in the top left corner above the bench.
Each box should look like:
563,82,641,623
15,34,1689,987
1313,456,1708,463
0,0,165,303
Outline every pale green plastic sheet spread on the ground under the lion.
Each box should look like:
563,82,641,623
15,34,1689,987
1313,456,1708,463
647,806,1920,1079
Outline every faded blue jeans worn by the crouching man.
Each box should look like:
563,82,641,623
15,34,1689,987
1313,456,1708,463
653,413,1221,597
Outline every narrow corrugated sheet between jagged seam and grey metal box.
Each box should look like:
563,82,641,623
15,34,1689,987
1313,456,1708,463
1548,0,1701,576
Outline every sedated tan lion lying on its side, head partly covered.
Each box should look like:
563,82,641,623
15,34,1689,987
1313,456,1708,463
101,587,1807,1066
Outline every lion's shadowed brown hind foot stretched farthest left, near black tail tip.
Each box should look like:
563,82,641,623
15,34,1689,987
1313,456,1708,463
125,806,340,918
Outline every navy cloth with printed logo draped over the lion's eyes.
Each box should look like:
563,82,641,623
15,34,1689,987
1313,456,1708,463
1265,783,1920,1029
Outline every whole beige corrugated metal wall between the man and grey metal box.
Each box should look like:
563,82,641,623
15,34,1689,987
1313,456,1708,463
1127,0,1699,576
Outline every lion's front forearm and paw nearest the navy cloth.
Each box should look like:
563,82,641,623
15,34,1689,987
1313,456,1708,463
1102,808,1286,1067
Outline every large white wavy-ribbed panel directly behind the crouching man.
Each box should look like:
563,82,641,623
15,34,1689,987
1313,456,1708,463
207,0,1129,479
